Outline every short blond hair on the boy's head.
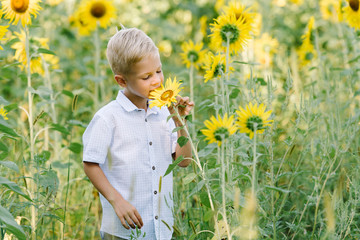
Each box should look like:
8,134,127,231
106,28,159,75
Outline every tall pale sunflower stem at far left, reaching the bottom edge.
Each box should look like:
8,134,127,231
24,26,37,239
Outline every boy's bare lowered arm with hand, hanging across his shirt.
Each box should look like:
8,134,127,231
83,162,144,229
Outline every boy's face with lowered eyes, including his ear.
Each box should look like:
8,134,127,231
115,54,164,105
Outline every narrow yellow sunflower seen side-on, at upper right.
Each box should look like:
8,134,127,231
298,17,316,65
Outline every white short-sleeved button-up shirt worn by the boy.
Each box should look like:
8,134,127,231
83,91,177,240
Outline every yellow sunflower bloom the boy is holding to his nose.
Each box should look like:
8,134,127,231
149,77,183,108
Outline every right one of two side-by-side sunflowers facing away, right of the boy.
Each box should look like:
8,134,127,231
236,103,273,139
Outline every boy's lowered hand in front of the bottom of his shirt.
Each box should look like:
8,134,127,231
113,198,144,229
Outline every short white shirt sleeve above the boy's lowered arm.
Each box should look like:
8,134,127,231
83,114,112,164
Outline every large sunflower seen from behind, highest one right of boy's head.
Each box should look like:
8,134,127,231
209,11,251,54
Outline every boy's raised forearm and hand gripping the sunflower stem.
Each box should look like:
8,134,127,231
169,97,195,167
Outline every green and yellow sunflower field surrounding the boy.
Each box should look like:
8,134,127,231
0,0,360,240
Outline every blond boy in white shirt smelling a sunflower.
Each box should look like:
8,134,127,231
83,28,194,240
